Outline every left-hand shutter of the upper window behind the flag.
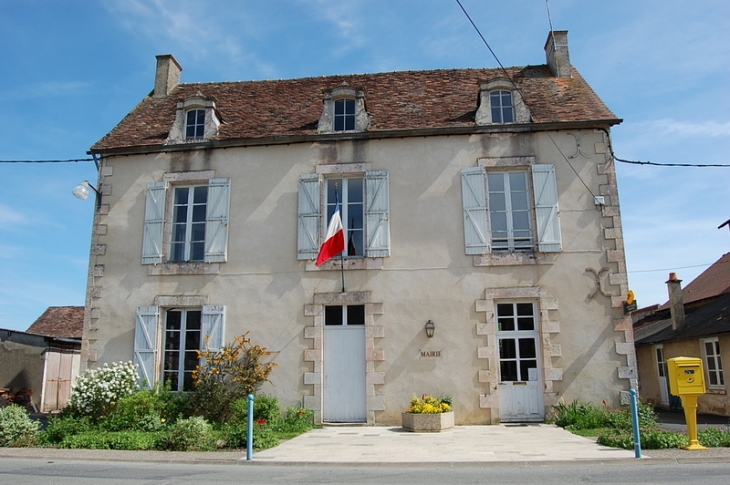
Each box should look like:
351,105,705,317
297,174,321,260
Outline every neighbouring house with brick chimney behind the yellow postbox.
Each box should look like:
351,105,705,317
634,253,730,416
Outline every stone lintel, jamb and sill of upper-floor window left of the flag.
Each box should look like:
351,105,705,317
146,170,220,276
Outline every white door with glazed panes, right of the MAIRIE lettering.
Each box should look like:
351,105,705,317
496,302,545,422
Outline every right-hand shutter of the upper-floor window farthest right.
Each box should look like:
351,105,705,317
532,164,563,253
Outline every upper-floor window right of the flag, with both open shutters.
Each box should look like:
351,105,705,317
461,162,562,254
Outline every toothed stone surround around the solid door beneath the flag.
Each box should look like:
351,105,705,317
303,291,385,426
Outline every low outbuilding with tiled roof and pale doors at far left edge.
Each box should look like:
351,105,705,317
0,306,84,412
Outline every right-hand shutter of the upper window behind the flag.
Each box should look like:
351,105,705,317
365,170,390,258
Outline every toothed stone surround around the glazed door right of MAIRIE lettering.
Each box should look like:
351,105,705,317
476,287,563,424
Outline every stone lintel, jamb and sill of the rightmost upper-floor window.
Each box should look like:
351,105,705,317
473,156,559,266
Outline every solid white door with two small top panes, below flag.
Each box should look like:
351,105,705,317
322,305,367,423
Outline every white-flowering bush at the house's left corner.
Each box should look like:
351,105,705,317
68,362,138,420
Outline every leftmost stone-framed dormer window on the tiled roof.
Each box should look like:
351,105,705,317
165,93,221,145
